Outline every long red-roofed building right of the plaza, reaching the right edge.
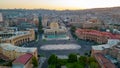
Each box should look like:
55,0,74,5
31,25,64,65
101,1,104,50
76,29,120,44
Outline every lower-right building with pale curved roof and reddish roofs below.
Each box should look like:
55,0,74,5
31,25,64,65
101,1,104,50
91,39,120,68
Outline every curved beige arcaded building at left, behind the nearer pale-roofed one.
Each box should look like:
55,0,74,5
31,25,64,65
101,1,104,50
0,29,35,46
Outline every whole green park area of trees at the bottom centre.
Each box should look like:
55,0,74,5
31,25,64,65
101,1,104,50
48,54,99,68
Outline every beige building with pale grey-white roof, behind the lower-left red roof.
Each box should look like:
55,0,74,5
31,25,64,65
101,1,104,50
0,43,37,60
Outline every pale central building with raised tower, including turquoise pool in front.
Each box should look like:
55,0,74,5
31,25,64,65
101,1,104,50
42,22,69,40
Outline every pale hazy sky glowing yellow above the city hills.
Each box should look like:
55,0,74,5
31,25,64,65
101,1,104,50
0,0,120,9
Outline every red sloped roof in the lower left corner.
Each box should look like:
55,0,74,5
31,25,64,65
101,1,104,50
13,53,32,65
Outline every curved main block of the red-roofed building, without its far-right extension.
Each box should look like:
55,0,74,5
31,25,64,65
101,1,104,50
76,29,108,44
